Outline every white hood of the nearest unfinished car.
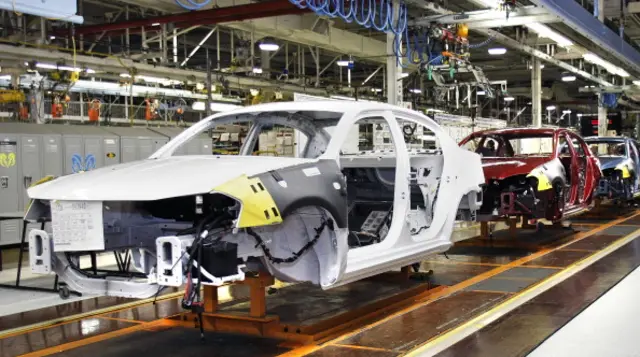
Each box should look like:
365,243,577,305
27,155,316,201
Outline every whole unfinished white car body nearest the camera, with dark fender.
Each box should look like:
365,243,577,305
26,101,484,298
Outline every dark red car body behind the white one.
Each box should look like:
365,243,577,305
460,128,600,221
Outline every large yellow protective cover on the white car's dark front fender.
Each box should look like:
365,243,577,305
214,175,282,228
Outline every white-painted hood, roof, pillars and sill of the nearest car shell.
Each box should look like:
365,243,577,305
27,101,485,297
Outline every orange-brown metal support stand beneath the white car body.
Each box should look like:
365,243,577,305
169,266,444,343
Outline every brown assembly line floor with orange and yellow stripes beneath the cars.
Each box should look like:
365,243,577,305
0,208,640,357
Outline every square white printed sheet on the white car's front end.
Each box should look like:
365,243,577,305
51,201,104,252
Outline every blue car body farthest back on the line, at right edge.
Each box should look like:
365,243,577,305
585,137,640,201
